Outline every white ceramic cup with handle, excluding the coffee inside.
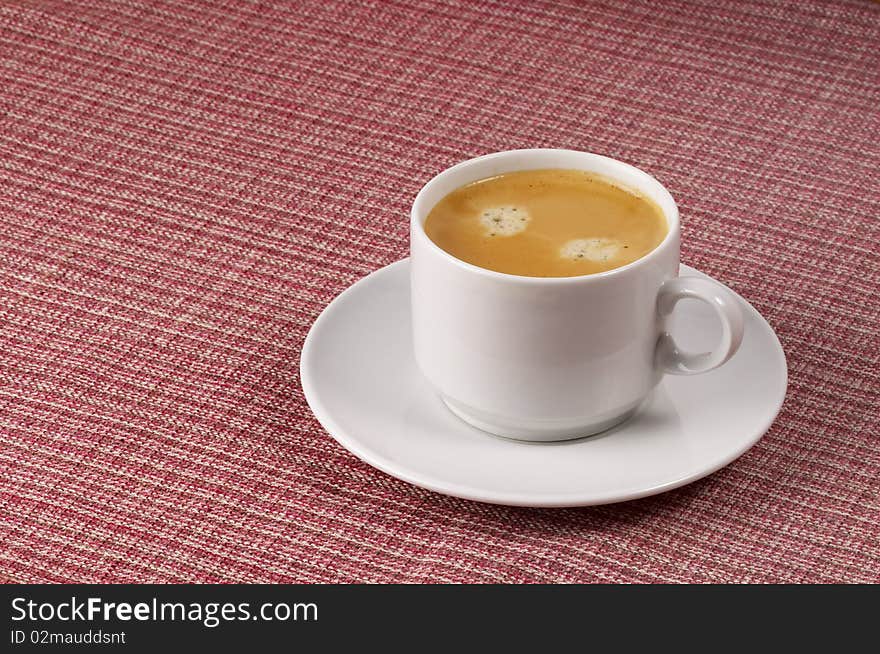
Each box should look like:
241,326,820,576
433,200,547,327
410,149,743,441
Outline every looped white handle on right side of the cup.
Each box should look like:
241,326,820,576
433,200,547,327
656,277,743,375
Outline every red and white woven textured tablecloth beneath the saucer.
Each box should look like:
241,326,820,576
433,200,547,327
0,0,880,582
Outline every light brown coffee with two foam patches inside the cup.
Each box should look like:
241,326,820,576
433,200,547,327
425,169,669,277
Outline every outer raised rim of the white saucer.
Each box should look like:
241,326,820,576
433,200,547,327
299,257,788,508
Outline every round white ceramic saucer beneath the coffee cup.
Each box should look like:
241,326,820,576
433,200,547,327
300,259,787,507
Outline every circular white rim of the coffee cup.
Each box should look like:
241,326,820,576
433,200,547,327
410,148,680,285
